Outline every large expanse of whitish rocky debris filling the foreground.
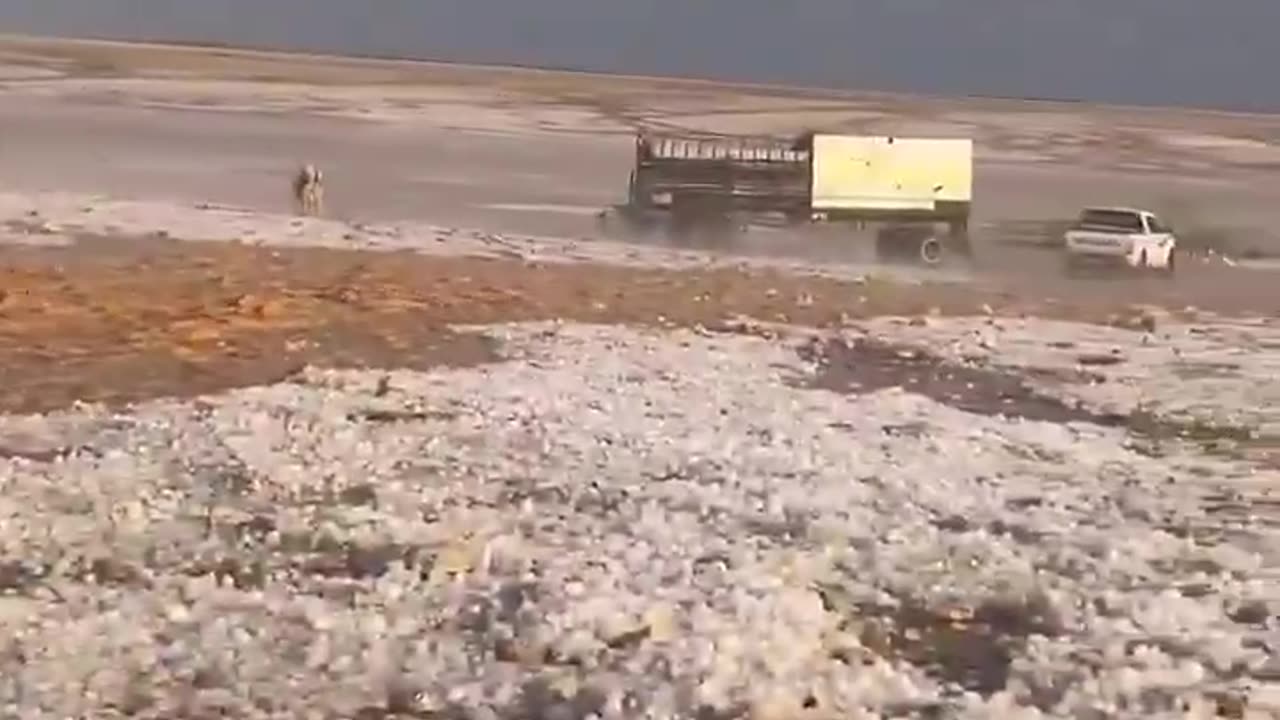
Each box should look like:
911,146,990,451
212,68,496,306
0,324,1280,719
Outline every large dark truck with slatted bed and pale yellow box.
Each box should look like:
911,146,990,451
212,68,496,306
604,132,973,265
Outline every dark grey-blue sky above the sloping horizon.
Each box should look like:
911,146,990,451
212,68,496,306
0,0,1280,110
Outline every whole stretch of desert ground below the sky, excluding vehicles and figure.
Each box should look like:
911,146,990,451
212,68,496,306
0,32,1280,720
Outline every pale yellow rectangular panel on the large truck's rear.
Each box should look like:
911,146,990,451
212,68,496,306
810,135,973,210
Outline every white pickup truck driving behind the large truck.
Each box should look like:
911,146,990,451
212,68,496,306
1064,208,1178,274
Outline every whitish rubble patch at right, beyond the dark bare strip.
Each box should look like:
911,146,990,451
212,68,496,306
849,318,1280,451
